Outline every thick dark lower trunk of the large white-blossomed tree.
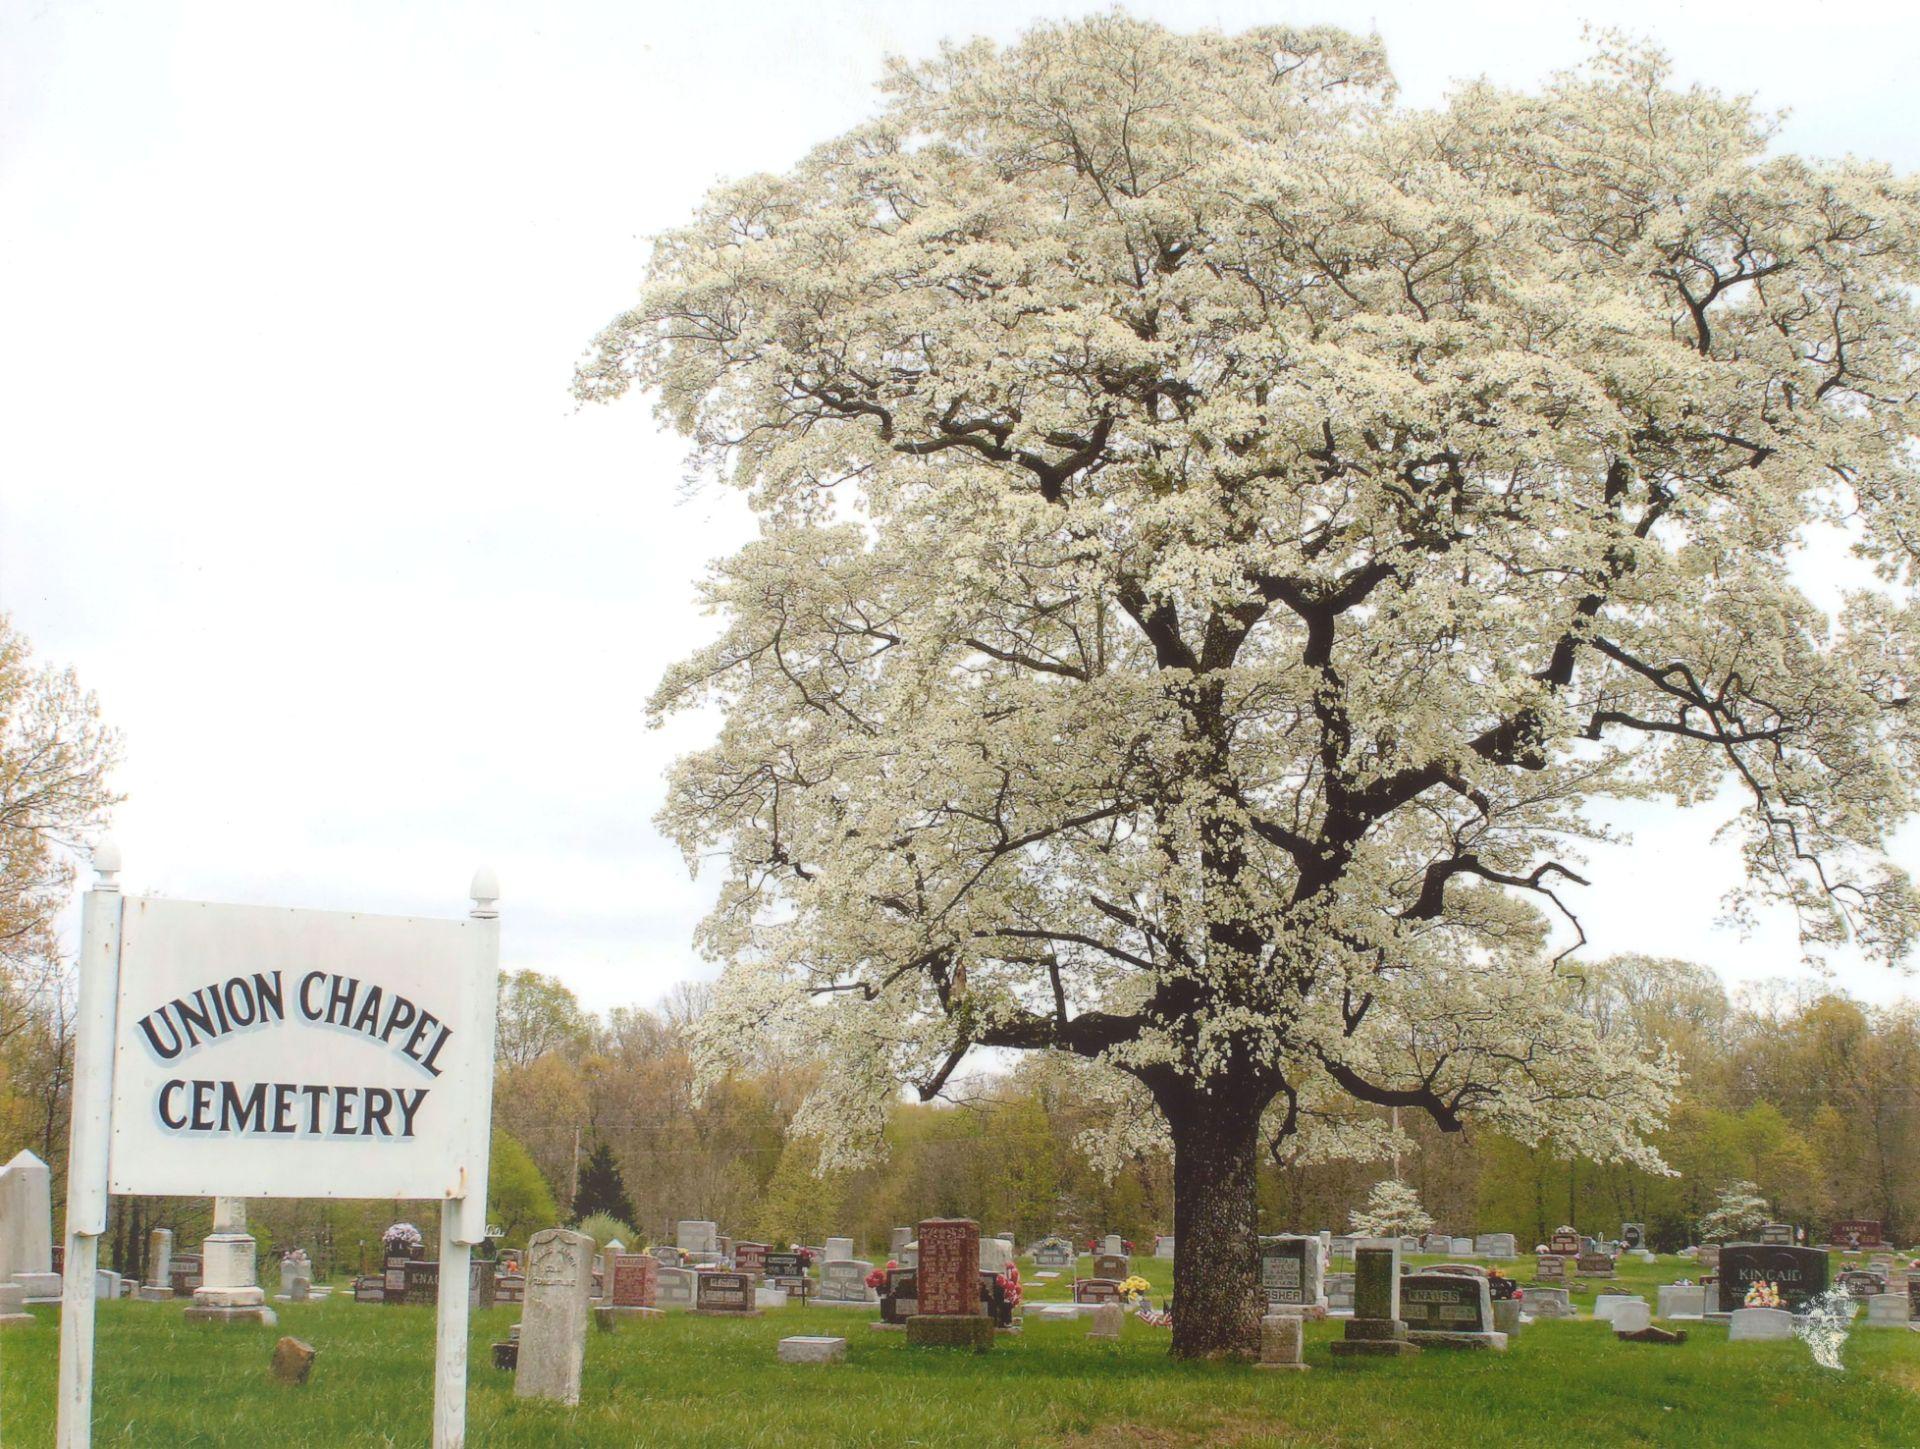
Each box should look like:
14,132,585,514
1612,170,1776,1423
1160,1084,1271,1359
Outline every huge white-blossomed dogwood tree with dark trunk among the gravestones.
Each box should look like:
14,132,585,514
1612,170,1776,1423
576,15,1920,1355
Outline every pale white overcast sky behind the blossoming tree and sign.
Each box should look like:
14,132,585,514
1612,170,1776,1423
0,0,1920,1008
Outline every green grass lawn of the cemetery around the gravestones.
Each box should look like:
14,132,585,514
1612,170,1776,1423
0,1259,1920,1449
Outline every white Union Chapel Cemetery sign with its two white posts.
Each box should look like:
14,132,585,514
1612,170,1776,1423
58,843,499,1449
